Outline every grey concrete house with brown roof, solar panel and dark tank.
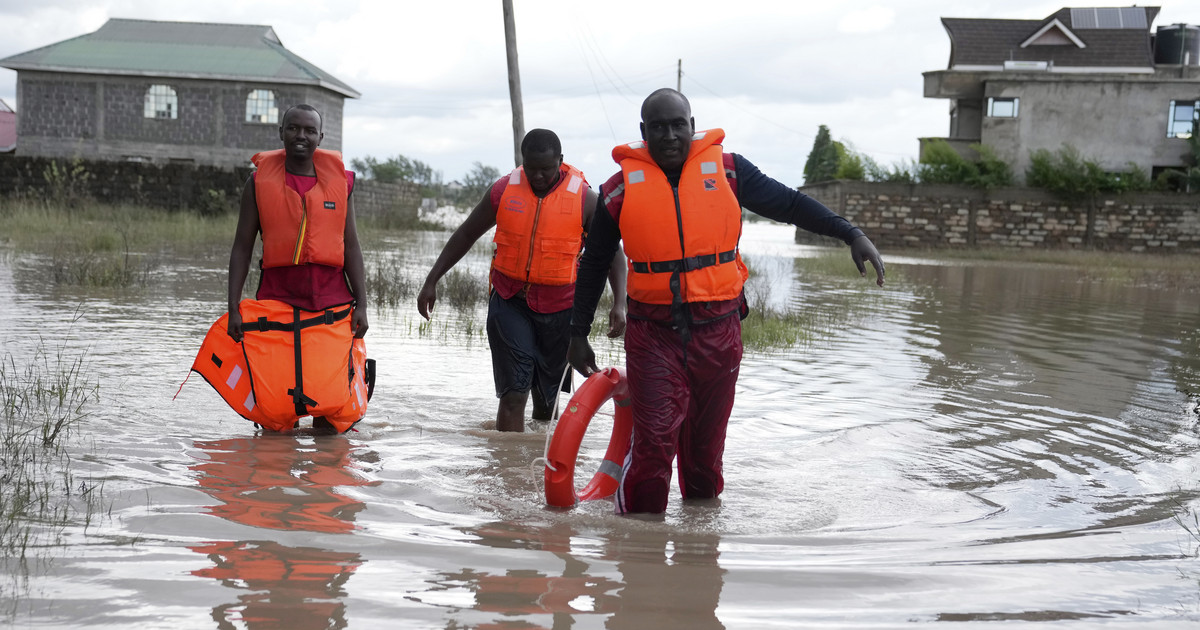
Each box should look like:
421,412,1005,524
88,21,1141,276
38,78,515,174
922,7,1200,178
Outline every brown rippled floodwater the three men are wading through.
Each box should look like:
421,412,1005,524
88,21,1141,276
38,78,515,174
0,224,1200,630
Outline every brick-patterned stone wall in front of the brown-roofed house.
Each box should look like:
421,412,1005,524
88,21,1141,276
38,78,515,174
797,181,1200,253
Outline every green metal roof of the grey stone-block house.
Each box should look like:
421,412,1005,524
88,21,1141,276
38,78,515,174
0,18,362,98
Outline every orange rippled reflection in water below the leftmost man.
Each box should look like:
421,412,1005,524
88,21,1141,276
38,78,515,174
188,434,372,629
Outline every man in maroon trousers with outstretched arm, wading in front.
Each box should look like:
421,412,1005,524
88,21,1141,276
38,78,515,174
569,89,883,514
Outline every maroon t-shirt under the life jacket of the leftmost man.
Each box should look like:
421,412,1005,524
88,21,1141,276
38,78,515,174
256,170,354,311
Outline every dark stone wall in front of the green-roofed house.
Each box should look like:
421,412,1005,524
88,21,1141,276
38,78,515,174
0,154,421,223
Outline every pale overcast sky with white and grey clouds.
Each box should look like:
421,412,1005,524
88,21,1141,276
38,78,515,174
0,0,1200,186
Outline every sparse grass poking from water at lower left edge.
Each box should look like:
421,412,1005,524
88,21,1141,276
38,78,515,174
0,331,104,614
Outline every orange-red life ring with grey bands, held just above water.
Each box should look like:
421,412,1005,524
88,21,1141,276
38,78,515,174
546,367,634,508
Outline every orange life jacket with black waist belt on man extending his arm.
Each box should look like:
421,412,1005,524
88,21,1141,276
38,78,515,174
612,130,749,304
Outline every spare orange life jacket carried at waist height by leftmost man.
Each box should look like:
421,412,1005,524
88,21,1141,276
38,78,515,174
192,300,374,433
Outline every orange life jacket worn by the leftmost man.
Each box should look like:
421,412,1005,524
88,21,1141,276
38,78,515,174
250,149,349,268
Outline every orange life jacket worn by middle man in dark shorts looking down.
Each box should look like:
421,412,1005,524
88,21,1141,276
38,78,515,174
492,163,587,286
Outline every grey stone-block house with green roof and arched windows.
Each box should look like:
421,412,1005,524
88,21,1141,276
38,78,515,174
0,19,361,167
